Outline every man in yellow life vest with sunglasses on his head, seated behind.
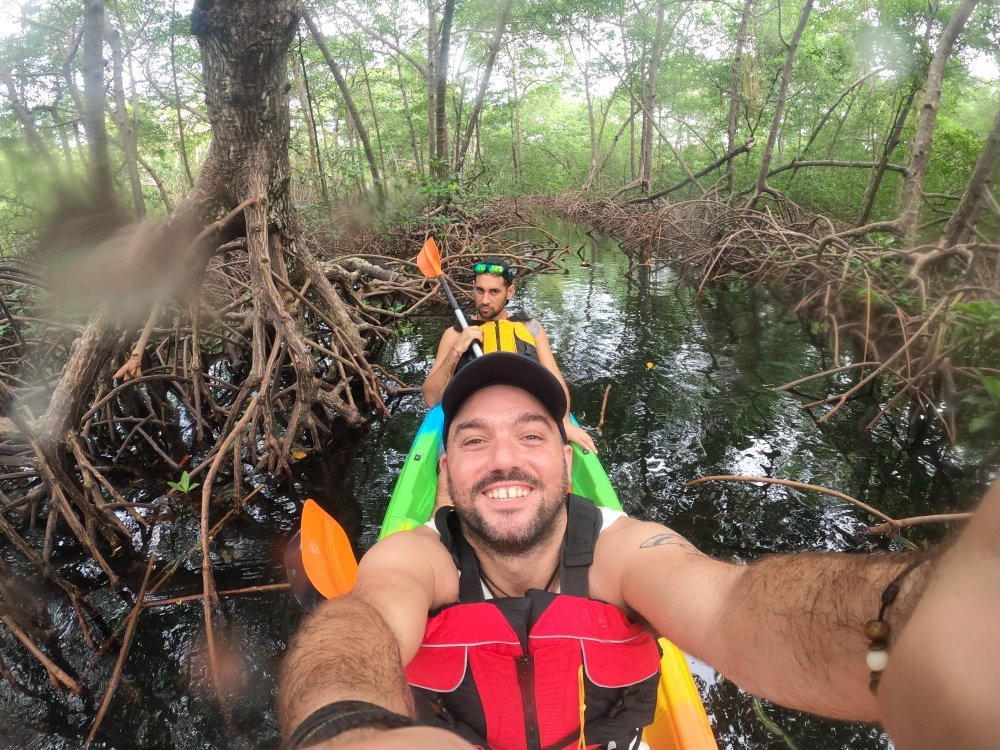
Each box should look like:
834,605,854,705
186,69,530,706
422,258,597,453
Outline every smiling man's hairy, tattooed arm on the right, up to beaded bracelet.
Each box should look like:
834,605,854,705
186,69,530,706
620,524,929,721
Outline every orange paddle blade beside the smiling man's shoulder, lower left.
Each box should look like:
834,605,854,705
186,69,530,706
301,498,358,599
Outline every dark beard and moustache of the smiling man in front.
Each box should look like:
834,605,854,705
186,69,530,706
448,464,569,557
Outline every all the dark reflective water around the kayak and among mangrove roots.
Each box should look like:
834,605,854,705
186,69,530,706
0,224,989,750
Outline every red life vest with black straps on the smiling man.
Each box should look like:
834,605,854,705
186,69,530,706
406,495,660,750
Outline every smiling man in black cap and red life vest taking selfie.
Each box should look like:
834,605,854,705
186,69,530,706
278,353,1000,750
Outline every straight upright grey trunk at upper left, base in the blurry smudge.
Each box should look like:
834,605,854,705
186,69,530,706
83,0,114,210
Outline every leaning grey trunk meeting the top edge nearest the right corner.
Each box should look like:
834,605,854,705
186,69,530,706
899,0,978,247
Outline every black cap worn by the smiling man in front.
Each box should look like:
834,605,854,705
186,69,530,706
441,352,566,440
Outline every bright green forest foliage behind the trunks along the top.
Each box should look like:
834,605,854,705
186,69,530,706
0,0,997,241
